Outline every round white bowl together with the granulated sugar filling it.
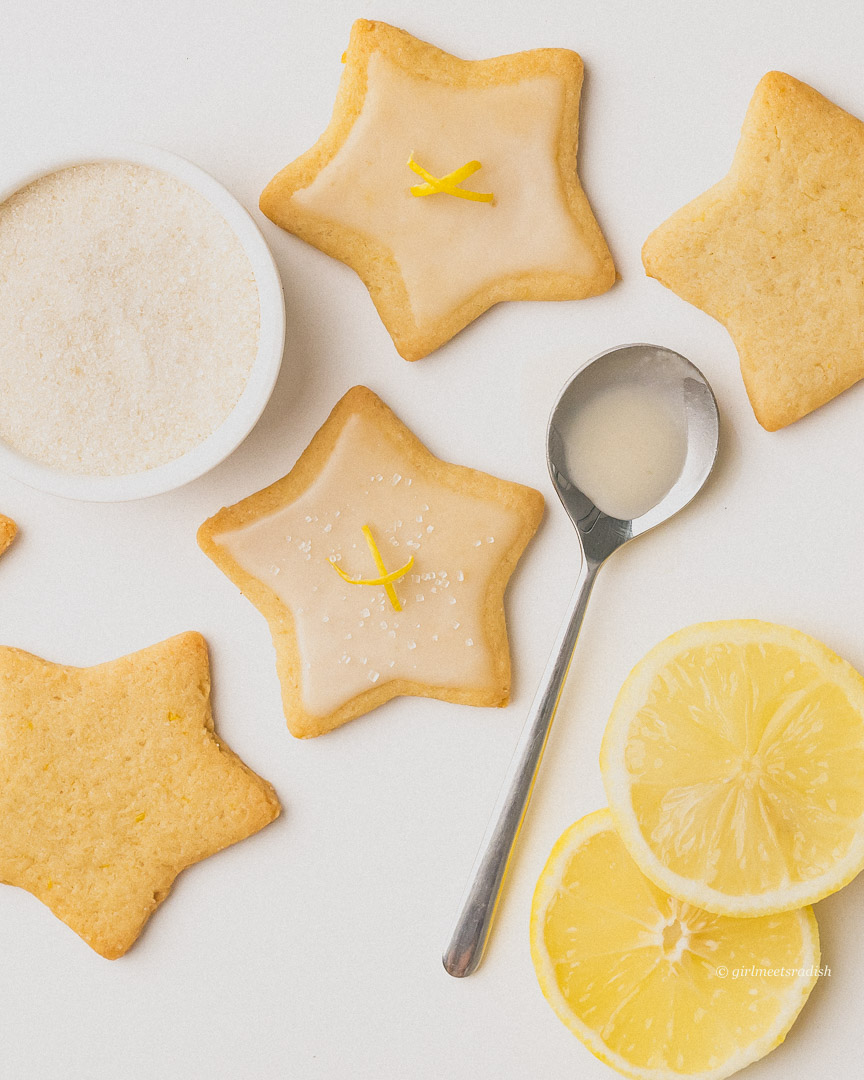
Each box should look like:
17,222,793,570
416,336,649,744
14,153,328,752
0,146,284,501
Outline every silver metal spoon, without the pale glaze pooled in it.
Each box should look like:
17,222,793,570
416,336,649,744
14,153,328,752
443,345,718,978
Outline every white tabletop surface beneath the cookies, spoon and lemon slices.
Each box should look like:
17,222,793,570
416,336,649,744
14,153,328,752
0,0,864,1080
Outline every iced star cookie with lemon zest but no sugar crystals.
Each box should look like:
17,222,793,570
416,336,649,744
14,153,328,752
260,19,616,360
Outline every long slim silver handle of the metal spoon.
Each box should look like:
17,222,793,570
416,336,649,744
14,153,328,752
443,559,599,978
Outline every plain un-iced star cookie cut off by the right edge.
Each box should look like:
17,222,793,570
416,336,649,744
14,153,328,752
643,71,864,431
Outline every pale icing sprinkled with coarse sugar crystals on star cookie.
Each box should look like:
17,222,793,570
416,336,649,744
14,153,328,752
215,415,521,715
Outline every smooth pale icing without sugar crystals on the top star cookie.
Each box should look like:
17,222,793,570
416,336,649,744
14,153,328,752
294,53,596,325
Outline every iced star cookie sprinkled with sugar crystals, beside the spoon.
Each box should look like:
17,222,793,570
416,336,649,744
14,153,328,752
198,387,543,738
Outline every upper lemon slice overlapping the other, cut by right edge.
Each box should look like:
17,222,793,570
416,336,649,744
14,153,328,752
600,621,864,916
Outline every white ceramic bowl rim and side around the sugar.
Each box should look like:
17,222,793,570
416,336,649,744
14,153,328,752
0,143,285,502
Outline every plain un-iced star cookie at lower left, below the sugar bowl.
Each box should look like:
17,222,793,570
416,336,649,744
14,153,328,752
0,633,280,959
